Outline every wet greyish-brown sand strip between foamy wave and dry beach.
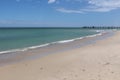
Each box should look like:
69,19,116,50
0,31,114,66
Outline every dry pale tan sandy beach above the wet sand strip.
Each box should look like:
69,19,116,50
0,31,120,80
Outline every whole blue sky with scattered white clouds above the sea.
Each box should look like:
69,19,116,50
0,0,120,27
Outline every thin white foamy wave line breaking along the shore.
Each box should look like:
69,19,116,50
0,30,102,54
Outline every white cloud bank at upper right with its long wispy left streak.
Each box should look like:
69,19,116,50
57,0,120,13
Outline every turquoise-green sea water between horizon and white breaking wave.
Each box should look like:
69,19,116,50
0,28,98,51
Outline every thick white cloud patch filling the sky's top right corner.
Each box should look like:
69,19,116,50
84,0,120,12
